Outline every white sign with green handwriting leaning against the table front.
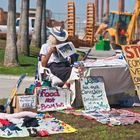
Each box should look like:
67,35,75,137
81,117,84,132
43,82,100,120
81,76,110,111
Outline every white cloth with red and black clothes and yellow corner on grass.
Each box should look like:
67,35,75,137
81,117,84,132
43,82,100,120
0,111,76,138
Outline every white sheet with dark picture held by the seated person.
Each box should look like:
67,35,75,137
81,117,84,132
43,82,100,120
56,42,76,58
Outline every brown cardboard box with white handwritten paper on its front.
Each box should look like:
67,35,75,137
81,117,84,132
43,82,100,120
11,94,37,113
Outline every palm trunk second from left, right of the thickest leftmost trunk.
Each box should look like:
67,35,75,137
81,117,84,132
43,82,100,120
17,0,29,56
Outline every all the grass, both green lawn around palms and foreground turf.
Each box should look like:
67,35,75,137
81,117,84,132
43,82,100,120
0,41,140,140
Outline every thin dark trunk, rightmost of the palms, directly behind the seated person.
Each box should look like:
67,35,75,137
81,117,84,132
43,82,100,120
41,0,46,44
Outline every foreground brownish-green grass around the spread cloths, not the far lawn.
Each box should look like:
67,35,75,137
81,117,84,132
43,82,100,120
0,97,140,140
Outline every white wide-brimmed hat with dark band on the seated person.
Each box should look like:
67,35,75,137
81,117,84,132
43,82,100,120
49,26,68,41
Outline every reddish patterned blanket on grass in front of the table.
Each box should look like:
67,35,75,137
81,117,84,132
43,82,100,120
61,108,140,126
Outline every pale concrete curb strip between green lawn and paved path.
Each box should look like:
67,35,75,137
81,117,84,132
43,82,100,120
0,74,35,81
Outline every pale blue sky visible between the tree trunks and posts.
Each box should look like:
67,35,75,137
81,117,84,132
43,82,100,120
0,0,135,20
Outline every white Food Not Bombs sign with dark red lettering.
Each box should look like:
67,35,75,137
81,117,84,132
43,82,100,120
37,88,71,112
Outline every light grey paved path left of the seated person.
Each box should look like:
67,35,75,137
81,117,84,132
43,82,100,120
0,75,34,99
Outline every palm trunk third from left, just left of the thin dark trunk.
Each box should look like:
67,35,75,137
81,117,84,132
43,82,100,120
31,0,43,48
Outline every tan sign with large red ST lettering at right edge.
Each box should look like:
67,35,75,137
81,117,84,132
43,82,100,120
122,45,140,99
